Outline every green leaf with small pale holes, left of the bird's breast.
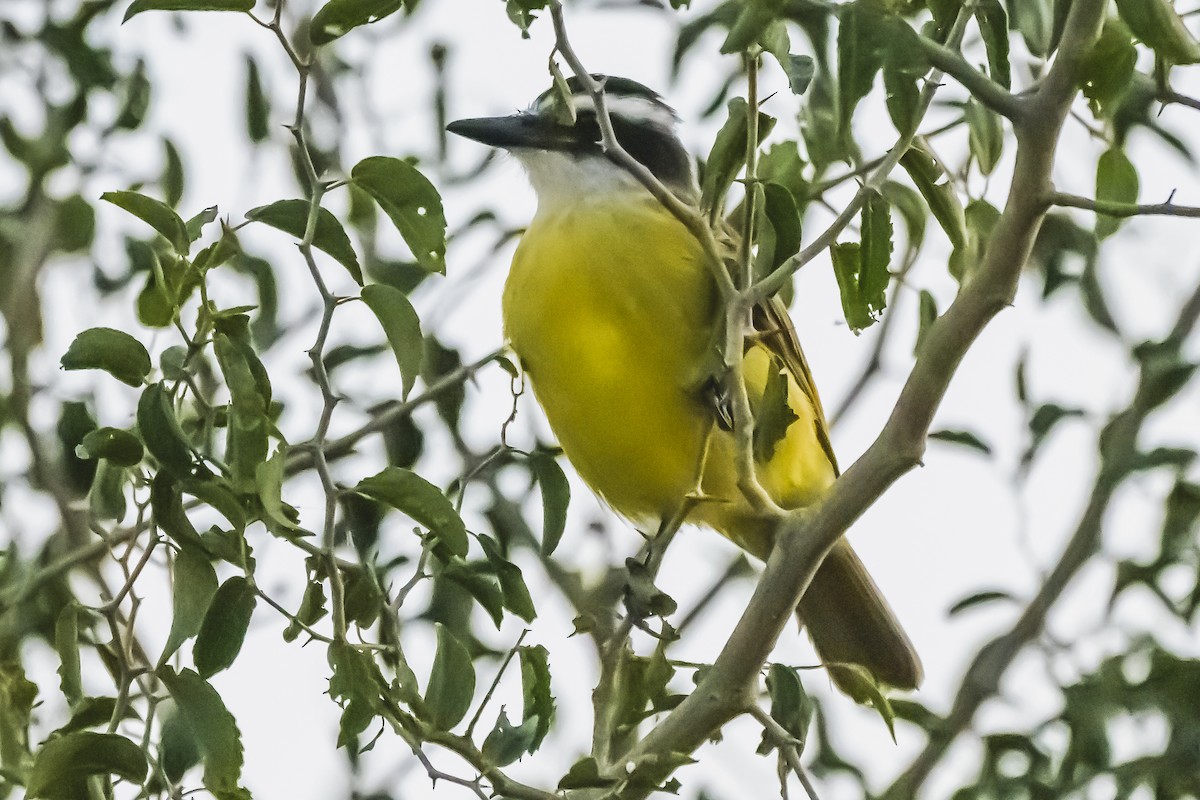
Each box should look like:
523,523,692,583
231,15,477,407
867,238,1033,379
350,156,446,275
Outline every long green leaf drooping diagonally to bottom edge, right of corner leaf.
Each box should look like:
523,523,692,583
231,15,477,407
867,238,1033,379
155,667,250,800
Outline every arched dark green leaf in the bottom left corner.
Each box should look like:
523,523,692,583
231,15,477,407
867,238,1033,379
25,730,148,800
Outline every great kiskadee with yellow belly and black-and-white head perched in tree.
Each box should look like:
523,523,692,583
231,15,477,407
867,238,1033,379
449,76,922,693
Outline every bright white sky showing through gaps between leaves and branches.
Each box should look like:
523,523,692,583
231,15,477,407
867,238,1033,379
9,0,1200,800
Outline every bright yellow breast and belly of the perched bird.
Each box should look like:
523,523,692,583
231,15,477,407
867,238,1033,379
503,197,834,551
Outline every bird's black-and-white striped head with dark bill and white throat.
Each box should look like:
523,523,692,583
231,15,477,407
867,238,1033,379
446,74,696,205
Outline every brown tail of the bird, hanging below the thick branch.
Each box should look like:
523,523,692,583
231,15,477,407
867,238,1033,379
797,540,924,700
